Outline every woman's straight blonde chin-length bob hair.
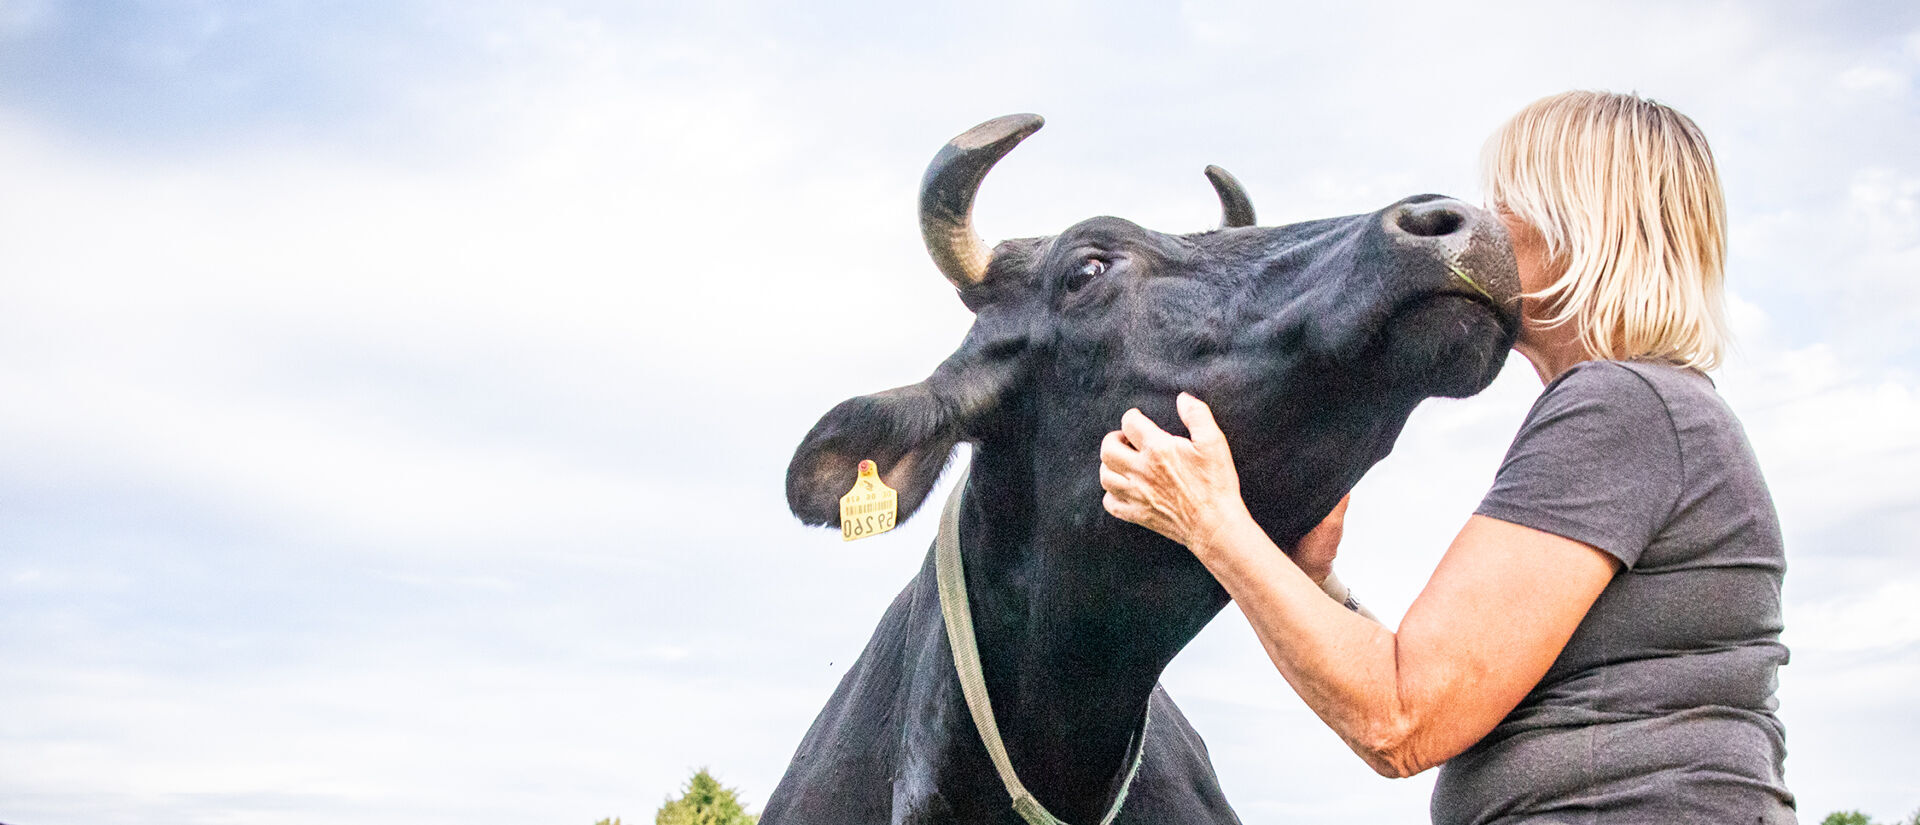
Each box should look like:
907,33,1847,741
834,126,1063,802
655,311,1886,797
1480,92,1728,370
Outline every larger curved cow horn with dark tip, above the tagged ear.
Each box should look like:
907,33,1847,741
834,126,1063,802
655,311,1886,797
920,115,1046,290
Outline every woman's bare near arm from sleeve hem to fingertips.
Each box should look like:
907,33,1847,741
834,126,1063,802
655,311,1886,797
1100,395,1617,777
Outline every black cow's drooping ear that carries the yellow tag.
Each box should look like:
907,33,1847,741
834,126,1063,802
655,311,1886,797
787,317,1027,528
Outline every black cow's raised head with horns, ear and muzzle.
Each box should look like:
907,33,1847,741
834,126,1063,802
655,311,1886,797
787,115,1519,545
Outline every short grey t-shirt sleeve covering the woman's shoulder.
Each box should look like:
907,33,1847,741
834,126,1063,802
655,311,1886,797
1475,361,1682,568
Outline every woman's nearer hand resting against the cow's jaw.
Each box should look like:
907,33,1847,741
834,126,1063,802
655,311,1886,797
1100,393,1251,556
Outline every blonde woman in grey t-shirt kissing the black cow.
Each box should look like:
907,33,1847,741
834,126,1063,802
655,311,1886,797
1100,92,1793,825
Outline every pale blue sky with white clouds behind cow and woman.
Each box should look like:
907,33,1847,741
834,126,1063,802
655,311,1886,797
0,0,1920,825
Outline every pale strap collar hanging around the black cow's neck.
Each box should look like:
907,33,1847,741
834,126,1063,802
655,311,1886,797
933,472,1150,825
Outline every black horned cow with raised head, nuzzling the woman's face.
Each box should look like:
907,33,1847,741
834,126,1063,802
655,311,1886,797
760,115,1519,825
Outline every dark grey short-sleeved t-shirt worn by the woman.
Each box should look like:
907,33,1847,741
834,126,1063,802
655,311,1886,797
1432,361,1793,825
